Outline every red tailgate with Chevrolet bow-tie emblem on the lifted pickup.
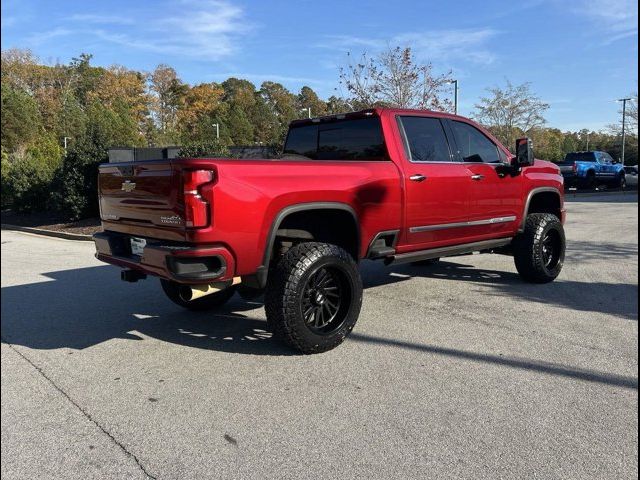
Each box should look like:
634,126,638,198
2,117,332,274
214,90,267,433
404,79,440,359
98,160,185,239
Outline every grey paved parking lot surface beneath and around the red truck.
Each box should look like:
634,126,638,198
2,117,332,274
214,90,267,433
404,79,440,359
1,196,638,479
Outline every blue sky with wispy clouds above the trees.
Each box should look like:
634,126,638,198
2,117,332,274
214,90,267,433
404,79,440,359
2,0,638,130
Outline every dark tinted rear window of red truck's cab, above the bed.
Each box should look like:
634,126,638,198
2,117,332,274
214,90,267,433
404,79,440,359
283,116,388,161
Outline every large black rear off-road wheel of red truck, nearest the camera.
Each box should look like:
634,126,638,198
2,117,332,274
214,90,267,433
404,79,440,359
265,242,362,354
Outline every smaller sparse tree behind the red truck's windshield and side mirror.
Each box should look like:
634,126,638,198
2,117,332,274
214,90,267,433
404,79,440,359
473,80,549,148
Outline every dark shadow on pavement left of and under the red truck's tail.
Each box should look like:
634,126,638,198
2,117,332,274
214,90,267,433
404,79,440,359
0,266,292,355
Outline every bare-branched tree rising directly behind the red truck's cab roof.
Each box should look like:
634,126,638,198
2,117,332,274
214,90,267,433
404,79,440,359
340,47,453,111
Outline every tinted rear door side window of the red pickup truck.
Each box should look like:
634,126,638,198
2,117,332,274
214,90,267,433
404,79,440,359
400,116,452,162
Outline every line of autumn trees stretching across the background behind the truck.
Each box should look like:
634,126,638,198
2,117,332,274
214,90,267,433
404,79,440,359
1,48,637,218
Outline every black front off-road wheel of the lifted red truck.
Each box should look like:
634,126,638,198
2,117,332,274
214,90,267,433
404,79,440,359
513,213,566,283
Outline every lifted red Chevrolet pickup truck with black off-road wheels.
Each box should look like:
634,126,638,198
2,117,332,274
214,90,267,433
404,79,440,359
94,108,565,353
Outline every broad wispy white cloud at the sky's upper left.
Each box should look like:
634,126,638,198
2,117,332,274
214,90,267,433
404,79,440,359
30,0,251,61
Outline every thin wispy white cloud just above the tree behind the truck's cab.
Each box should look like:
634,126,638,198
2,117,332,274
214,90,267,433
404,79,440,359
316,28,499,64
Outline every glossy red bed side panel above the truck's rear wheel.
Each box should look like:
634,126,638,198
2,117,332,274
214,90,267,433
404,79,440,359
180,159,401,275
